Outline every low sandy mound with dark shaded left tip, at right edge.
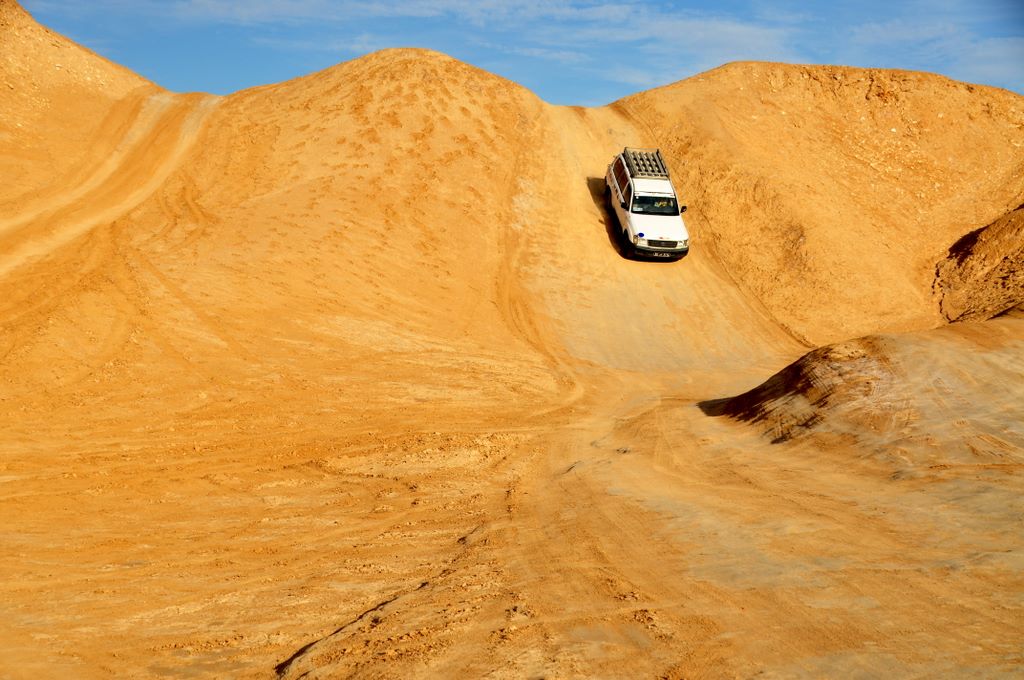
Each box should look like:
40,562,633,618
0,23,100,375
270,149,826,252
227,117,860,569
705,311,1024,458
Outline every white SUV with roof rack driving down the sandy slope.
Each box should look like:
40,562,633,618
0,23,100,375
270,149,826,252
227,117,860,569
604,146,690,260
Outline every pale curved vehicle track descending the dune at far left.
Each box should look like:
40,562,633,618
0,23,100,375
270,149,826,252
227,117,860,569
0,93,218,277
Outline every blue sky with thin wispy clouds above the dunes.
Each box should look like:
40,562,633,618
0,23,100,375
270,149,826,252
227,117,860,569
23,0,1024,105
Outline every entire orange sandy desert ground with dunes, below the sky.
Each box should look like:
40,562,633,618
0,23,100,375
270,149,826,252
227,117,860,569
0,0,1024,679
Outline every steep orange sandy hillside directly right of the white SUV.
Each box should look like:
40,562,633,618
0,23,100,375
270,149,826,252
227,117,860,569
622,63,1024,343
